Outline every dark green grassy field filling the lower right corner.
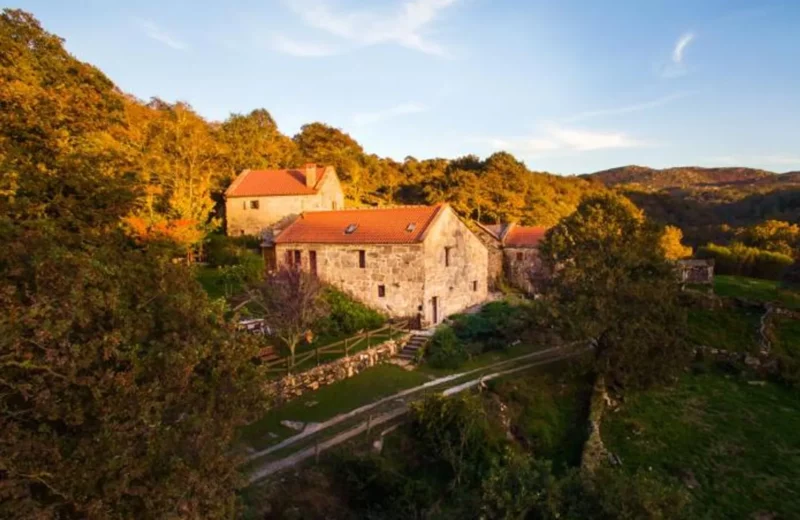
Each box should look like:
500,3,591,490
602,373,800,519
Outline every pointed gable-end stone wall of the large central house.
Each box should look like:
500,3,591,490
423,207,489,325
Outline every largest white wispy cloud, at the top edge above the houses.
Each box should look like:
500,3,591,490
273,0,458,57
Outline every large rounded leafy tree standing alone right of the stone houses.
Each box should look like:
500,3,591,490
540,194,688,387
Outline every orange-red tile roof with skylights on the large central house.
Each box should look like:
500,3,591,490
275,204,446,244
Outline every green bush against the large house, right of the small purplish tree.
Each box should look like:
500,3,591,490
314,287,386,343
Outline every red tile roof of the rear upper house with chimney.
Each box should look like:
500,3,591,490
225,166,326,197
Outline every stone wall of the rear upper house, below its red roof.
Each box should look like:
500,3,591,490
225,172,344,236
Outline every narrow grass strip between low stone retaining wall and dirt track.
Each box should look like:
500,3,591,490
242,365,430,449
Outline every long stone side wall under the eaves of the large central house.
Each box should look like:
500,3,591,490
275,244,425,318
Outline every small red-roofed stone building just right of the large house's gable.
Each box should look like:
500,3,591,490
475,222,547,293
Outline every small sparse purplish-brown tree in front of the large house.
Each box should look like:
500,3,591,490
247,266,326,365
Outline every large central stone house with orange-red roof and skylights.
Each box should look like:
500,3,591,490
264,204,488,326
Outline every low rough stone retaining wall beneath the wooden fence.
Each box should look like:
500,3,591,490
266,335,409,406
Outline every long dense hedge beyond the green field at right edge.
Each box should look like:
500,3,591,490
697,242,794,280
